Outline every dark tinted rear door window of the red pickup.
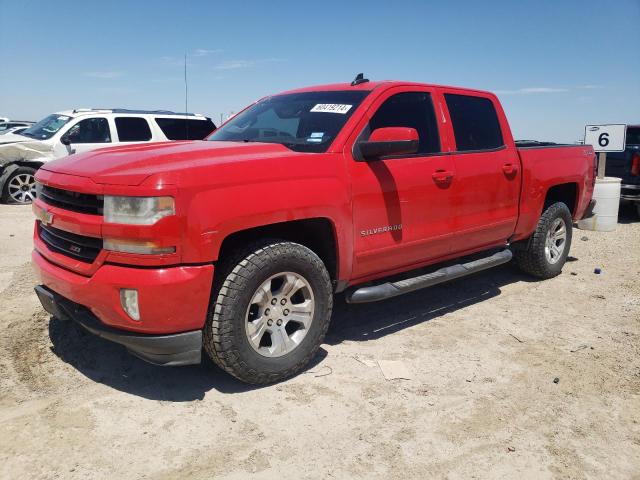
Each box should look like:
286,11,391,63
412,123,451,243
444,93,504,152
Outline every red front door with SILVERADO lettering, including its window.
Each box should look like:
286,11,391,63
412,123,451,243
347,87,454,279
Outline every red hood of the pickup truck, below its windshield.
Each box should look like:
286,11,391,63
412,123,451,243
42,141,299,186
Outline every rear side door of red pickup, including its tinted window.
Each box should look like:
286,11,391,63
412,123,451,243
442,89,521,253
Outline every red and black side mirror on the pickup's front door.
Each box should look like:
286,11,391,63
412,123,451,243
358,127,420,161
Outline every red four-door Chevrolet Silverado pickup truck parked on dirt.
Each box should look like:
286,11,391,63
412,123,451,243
33,76,595,384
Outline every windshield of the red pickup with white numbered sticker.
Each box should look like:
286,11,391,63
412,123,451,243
208,90,369,153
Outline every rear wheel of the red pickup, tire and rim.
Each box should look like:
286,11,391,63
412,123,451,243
514,202,573,278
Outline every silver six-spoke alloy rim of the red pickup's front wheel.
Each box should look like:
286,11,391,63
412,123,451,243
245,272,315,358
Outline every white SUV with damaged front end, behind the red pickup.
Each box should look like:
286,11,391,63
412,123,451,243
0,109,216,203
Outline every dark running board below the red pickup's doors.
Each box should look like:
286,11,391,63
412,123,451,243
346,249,513,303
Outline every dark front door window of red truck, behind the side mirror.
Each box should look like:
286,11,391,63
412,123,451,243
367,92,440,154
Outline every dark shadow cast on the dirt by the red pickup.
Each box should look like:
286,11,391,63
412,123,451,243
49,265,531,402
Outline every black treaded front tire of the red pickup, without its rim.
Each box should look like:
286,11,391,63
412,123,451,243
204,239,333,384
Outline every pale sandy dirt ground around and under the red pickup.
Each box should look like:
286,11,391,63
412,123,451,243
0,205,640,480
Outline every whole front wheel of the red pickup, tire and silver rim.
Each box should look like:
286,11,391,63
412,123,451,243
204,240,333,384
